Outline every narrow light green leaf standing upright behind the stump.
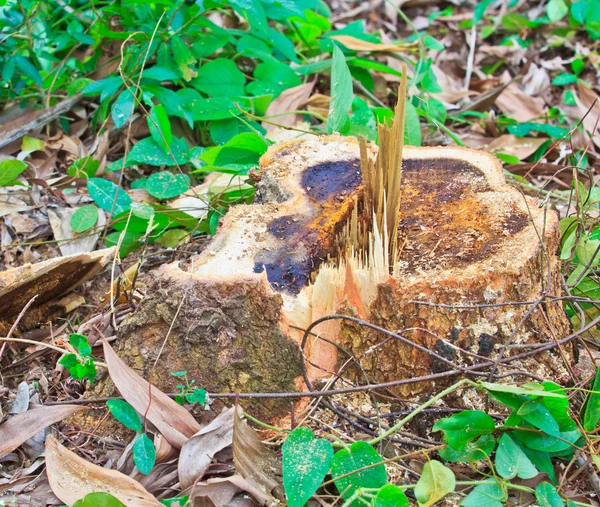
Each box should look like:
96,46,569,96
327,45,353,134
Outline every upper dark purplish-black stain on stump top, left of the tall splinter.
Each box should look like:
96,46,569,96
302,159,362,203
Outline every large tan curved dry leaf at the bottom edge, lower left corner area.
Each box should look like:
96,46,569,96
46,437,162,507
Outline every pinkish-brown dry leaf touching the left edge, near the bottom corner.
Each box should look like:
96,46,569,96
0,405,84,458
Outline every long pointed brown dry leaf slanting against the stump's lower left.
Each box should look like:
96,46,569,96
102,338,202,449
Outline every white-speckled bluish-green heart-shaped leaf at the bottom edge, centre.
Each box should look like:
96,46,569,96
282,426,333,507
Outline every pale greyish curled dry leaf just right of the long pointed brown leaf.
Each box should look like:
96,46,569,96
178,407,235,489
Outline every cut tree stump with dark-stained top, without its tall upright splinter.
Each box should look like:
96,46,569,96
103,136,569,415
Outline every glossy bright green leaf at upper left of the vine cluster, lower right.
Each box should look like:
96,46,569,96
433,410,496,451
